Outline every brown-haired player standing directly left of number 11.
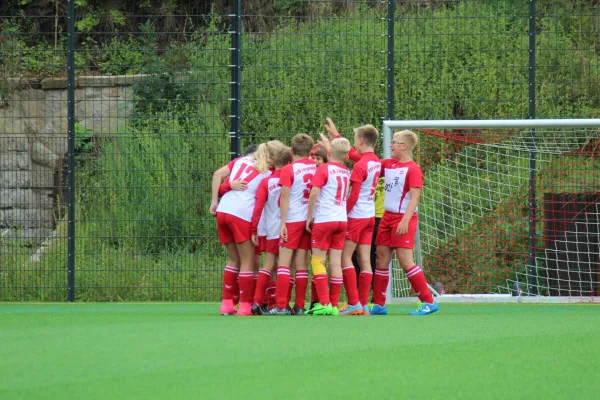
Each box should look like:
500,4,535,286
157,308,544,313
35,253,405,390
266,133,317,315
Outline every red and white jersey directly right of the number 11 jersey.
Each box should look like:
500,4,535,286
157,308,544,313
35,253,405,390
348,152,381,218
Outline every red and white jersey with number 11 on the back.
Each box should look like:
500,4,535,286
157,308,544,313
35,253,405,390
312,162,350,224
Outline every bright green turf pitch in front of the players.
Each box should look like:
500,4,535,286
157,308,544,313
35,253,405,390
0,303,600,400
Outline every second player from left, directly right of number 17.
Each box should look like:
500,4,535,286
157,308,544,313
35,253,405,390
252,148,292,314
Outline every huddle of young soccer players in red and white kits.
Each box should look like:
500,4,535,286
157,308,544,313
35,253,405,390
210,118,438,316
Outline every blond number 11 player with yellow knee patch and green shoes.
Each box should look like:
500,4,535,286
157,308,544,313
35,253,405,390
306,138,352,315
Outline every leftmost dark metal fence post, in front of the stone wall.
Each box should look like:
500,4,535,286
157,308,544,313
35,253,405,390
67,0,75,302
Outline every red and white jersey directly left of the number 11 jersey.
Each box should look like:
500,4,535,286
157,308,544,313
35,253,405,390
279,158,317,222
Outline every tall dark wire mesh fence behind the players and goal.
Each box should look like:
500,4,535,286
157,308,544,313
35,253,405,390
0,0,600,301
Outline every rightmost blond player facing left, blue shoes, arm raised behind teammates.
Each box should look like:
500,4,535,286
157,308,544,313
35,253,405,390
323,118,439,315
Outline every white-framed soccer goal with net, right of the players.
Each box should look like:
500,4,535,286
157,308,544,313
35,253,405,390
383,119,600,302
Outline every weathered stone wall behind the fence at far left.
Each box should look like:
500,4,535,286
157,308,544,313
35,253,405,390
0,75,136,246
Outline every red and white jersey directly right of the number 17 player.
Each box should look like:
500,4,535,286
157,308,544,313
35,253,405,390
256,170,281,240
